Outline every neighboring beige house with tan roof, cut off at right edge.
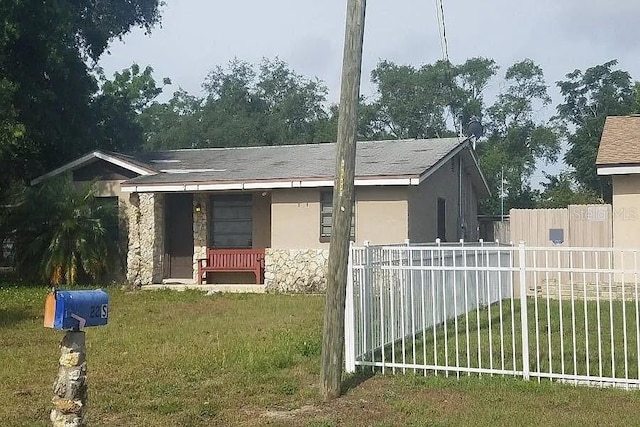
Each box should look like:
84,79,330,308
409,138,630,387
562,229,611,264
596,115,640,249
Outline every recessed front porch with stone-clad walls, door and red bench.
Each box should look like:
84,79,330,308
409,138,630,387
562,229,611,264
127,191,271,285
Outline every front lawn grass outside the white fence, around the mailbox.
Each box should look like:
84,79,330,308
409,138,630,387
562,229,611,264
0,285,640,427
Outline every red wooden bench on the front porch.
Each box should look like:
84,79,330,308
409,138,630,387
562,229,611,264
198,249,264,285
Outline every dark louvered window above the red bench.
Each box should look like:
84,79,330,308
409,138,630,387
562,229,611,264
209,194,253,249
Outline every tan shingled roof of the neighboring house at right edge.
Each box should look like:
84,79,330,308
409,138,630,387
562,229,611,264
596,115,640,175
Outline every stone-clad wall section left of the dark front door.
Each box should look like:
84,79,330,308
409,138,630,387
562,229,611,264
127,193,164,286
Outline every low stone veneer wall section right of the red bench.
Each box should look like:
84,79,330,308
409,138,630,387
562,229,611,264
264,248,329,293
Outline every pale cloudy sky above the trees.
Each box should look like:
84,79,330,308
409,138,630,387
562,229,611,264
99,0,640,181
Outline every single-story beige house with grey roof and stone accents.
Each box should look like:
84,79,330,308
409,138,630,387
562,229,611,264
34,138,489,291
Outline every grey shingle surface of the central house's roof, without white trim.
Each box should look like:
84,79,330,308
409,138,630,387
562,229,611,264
126,138,461,185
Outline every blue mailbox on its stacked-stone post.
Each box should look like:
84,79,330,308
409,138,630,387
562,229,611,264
44,289,109,427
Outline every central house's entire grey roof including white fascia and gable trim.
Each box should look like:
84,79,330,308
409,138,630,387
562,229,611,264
33,138,489,194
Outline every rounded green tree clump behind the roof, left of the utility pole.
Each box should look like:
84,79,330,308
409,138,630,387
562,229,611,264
141,58,335,149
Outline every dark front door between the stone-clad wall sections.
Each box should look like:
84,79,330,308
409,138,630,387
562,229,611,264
164,194,193,279
